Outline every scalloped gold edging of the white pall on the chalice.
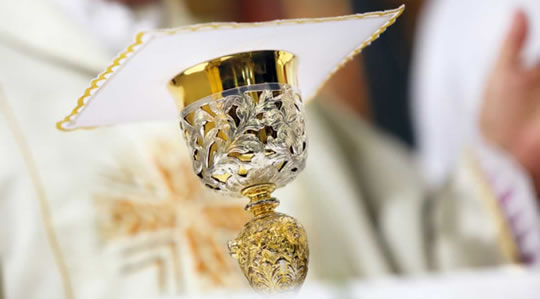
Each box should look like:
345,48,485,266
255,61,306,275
56,5,405,132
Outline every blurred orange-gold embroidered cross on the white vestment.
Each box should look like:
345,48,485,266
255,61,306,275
95,138,249,293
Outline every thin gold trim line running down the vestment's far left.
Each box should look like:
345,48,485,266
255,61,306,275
0,86,74,299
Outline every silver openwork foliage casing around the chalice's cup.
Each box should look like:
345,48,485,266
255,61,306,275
180,83,307,196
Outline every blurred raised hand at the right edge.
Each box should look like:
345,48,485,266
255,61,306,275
480,11,540,194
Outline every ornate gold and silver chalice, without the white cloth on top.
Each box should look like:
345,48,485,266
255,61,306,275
169,50,309,293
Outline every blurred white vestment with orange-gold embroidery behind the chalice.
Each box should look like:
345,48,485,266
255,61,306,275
0,0,536,299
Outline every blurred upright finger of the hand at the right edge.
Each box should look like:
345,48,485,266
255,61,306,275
499,9,528,66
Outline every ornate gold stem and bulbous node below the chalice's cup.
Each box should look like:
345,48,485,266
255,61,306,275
229,184,309,293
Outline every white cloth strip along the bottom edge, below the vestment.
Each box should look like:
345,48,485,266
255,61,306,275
148,268,540,299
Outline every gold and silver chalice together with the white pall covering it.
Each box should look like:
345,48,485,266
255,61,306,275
57,6,404,293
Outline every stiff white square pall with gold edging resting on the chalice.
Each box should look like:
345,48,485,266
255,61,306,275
57,6,404,131
